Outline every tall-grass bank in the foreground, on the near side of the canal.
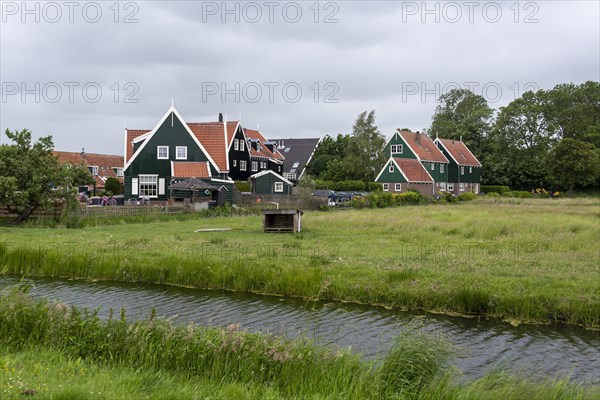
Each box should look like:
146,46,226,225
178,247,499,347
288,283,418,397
0,290,600,399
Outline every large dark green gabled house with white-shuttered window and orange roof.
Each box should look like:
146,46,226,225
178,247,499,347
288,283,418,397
123,107,233,202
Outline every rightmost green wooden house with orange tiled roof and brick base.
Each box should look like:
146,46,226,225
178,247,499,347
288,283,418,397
435,138,481,196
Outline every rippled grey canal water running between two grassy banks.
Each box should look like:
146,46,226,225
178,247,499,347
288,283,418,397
0,276,600,385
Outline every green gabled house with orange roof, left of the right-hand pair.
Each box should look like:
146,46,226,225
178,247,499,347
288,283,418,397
376,129,449,196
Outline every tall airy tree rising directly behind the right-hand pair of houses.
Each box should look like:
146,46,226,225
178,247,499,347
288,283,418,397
429,89,494,160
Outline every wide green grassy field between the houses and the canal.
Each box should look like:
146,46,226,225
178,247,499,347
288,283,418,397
0,199,600,328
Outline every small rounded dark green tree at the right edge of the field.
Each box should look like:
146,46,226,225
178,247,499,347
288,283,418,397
547,137,600,197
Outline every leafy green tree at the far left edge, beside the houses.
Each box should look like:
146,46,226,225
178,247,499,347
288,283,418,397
0,129,89,225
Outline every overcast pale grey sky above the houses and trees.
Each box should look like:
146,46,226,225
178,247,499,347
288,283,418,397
0,0,600,154
